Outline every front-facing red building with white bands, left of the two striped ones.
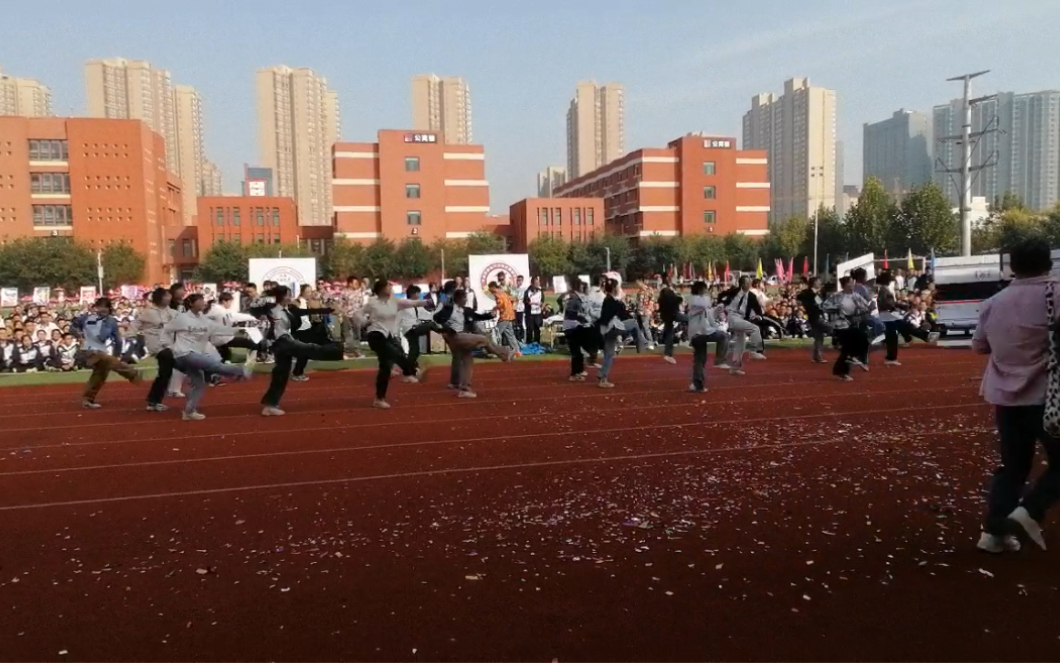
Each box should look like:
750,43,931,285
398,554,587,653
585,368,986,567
332,129,495,243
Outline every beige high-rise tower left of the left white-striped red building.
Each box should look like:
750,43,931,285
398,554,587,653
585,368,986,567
257,66,340,226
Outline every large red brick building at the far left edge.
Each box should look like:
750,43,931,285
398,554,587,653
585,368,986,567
0,117,182,282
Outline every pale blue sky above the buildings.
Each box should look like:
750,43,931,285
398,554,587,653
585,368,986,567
0,0,1060,211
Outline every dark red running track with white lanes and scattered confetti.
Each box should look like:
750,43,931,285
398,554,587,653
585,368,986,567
0,349,1060,661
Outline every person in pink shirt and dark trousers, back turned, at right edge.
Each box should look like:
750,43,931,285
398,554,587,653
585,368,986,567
972,240,1060,553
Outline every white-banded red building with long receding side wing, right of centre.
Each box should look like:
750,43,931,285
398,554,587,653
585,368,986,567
553,134,770,237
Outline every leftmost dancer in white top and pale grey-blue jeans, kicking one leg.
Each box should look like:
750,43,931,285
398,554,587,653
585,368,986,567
162,294,251,421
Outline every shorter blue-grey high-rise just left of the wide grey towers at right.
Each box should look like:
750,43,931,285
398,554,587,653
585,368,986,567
862,108,934,195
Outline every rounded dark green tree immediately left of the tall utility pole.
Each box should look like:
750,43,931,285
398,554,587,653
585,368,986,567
890,182,960,255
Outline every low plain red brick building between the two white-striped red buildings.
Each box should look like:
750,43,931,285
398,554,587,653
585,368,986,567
508,198,604,254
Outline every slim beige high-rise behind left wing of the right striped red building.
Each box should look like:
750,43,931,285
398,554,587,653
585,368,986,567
567,81,625,179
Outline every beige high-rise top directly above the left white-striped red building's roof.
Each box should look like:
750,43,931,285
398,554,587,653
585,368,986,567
412,73,474,145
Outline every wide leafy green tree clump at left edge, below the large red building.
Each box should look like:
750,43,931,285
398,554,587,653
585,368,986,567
0,238,96,292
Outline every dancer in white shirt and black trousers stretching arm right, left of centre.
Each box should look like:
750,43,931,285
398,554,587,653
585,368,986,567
363,279,429,409
